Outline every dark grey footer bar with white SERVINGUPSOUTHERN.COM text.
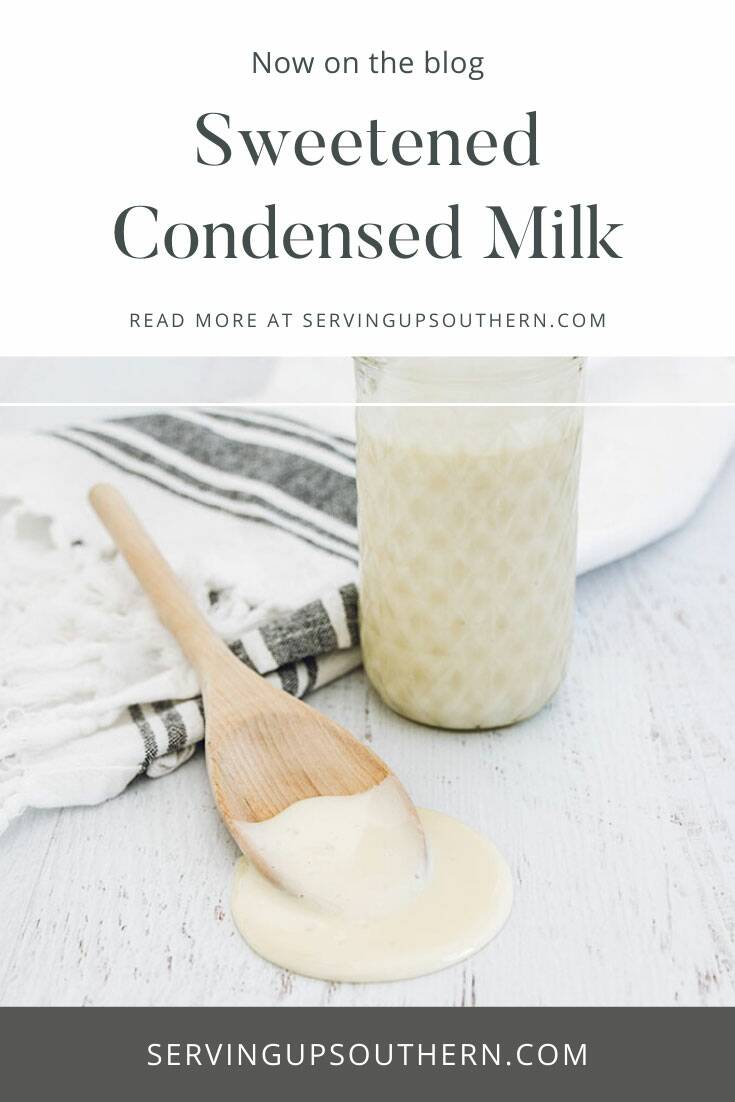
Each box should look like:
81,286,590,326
0,1007,735,1102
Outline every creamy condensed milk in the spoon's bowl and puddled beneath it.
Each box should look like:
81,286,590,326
233,778,512,982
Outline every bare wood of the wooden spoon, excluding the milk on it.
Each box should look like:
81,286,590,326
89,484,425,875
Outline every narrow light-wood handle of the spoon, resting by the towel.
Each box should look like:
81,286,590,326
89,483,231,680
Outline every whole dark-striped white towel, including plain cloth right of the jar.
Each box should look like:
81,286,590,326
0,359,735,830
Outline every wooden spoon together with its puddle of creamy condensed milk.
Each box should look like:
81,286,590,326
90,449,512,981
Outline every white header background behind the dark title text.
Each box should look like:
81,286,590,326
0,0,734,354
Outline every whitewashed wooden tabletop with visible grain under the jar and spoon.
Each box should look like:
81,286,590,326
0,409,735,1006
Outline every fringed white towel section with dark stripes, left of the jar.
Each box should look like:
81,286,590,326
0,410,359,831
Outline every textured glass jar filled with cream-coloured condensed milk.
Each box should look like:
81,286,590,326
355,358,583,730
